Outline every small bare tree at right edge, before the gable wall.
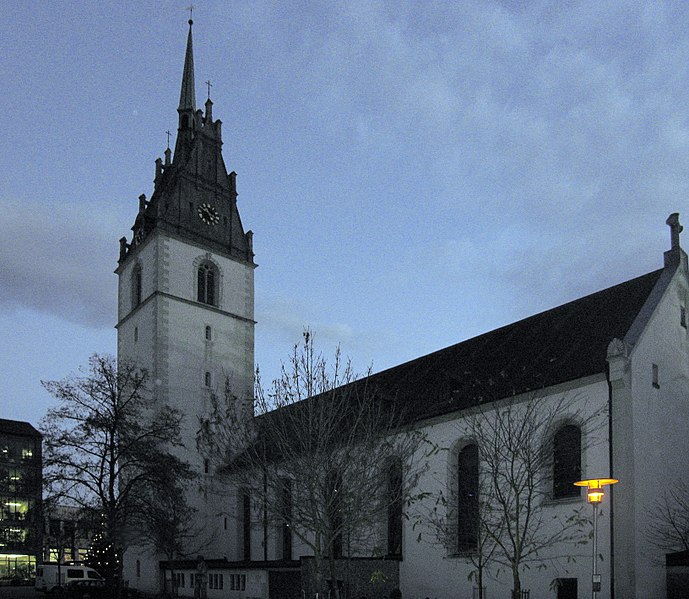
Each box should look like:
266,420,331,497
646,481,689,563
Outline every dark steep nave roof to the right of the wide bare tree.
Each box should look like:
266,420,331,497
369,269,663,422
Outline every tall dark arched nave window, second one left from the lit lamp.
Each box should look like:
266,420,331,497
457,444,479,553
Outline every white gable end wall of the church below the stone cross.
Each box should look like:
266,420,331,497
628,268,689,597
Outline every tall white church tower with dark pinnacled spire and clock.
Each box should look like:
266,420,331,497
115,20,256,472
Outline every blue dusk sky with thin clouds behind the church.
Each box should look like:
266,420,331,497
0,0,689,424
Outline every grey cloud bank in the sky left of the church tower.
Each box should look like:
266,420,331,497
0,200,117,328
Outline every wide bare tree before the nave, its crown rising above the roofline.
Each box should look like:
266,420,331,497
199,331,422,594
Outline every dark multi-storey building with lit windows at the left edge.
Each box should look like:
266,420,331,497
0,419,42,585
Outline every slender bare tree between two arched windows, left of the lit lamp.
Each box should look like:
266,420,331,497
422,392,605,597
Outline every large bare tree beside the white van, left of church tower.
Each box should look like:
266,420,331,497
41,354,189,596
